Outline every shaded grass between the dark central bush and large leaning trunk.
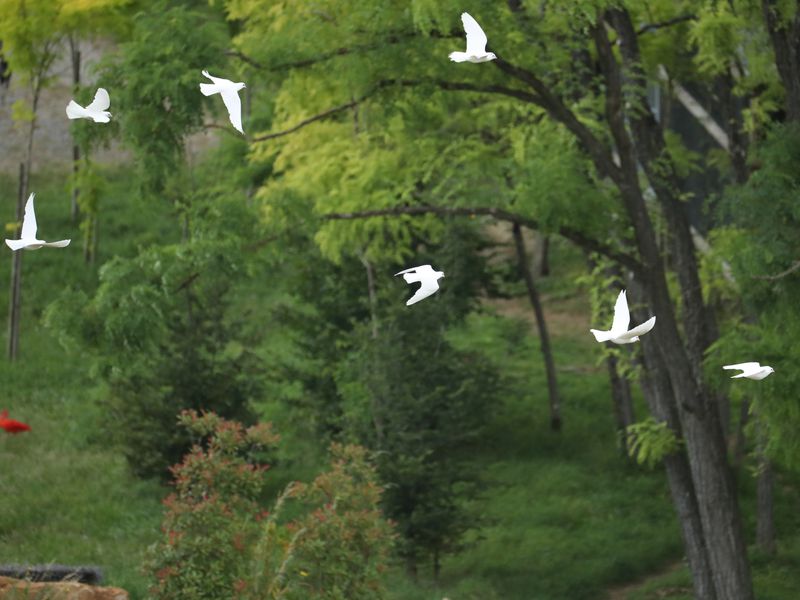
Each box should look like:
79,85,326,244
384,244,681,600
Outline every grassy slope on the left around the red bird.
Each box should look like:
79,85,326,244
0,169,175,597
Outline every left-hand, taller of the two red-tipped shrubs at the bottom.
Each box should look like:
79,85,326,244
145,411,278,600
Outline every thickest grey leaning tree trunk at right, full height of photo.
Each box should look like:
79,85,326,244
592,16,753,600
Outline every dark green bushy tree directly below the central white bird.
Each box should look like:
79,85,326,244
336,272,498,565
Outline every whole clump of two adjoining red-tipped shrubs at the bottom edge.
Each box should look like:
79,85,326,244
145,411,394,600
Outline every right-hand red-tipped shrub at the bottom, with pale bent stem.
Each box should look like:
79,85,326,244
252,444,394,600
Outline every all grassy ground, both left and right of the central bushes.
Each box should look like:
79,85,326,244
0,166,800,600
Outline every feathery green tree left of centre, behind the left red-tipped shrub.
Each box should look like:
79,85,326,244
47,196,263,476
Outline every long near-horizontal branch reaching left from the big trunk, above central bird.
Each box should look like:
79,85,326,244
323,206,643,273
